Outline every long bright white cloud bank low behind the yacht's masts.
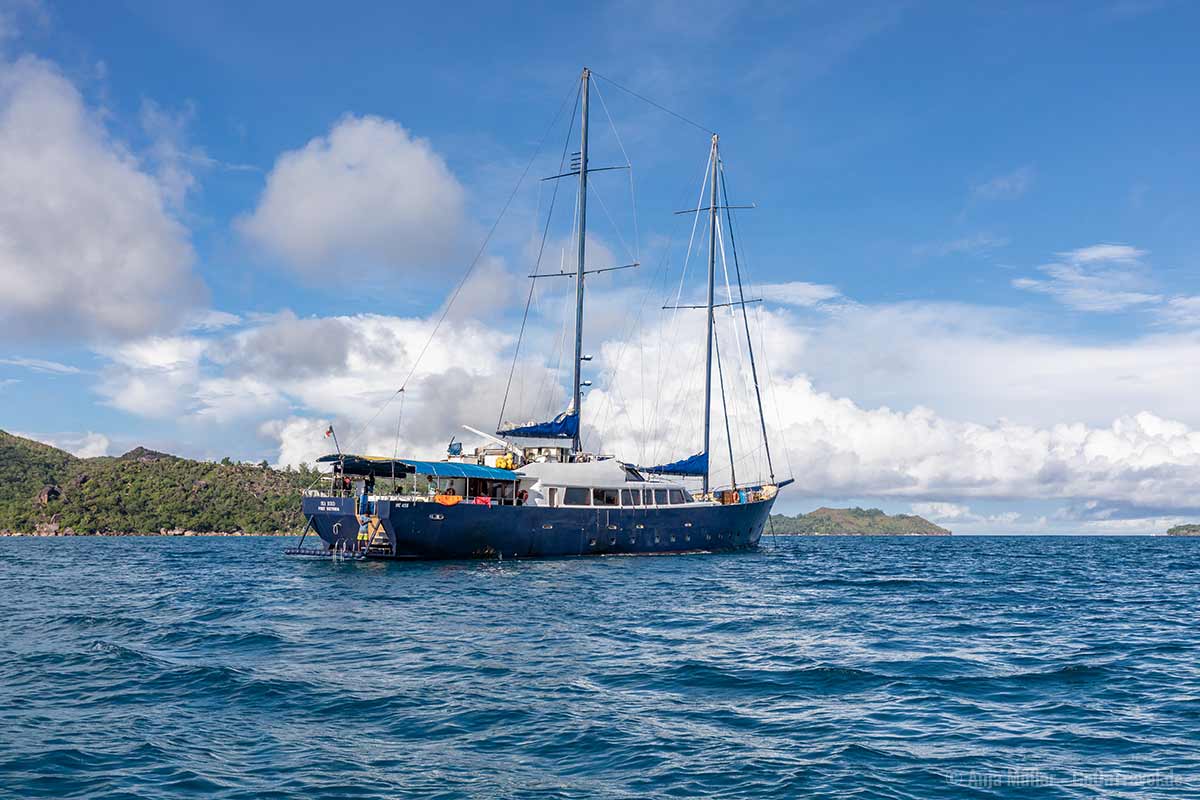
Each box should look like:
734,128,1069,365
77,261,1200,530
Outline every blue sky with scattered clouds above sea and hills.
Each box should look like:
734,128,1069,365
0,0,1200,534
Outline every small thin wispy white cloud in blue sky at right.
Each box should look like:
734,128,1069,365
1013,245,1163,312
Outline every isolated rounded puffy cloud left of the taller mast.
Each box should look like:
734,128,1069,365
238,115,464,275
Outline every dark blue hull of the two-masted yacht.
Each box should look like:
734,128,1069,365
295,497,774,559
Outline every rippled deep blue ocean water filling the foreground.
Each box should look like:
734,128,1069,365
0,537,1200,800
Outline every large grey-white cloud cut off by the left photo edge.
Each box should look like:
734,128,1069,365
0,58,204,339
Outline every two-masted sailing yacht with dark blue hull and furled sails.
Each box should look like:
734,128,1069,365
288,70,791,559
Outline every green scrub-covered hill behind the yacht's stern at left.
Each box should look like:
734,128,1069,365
0,431,314,534
